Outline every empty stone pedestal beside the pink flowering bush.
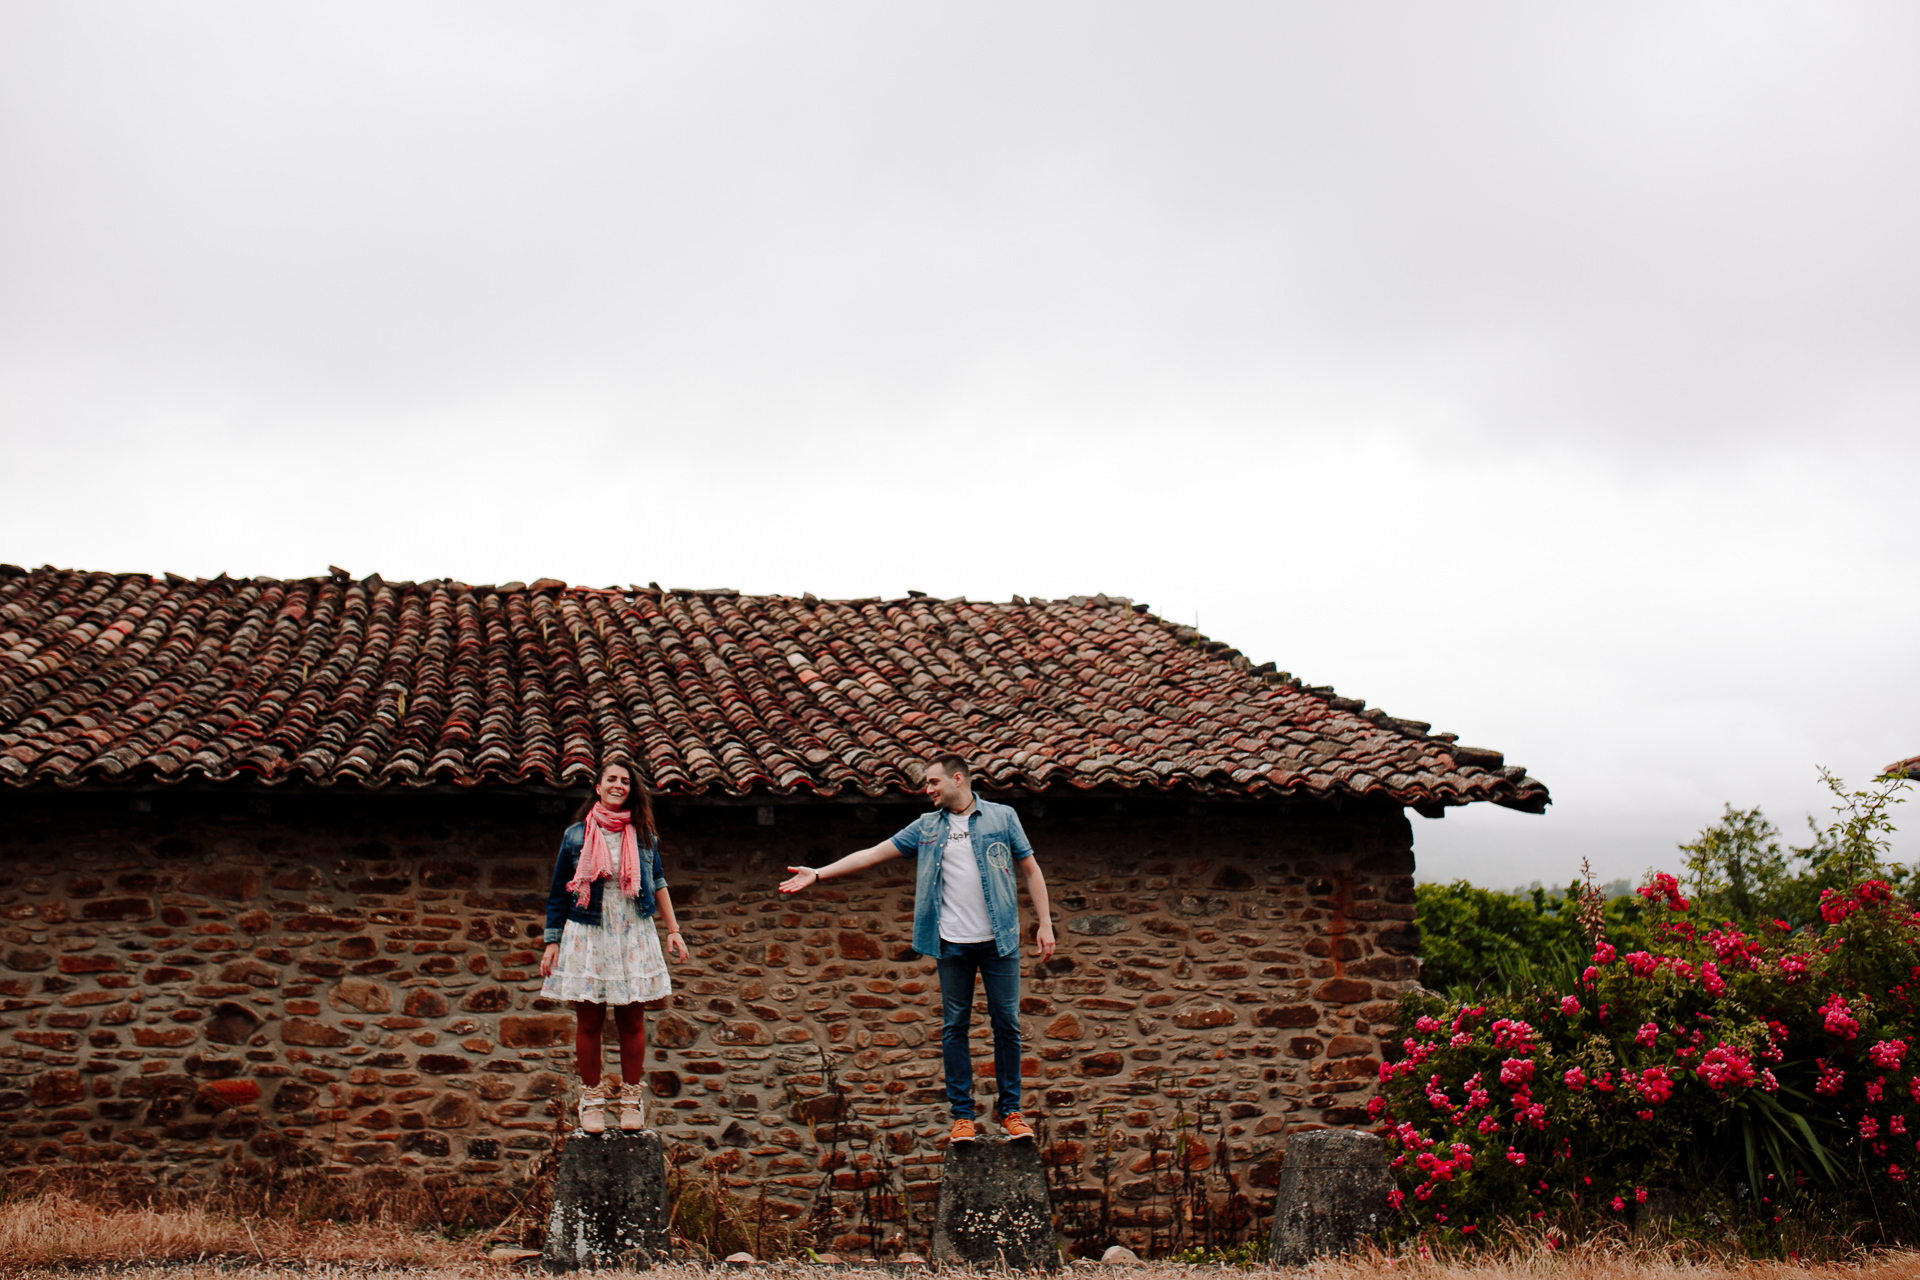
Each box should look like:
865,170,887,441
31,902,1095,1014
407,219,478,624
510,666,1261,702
1267,1128,1394,1267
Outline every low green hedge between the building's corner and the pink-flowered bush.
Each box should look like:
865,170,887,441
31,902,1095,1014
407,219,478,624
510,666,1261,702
1415,881,1642,1000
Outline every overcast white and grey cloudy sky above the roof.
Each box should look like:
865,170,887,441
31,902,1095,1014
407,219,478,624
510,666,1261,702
0,0,1920,885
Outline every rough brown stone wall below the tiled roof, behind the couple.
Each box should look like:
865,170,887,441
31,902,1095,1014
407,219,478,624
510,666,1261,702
0,791,1417,1249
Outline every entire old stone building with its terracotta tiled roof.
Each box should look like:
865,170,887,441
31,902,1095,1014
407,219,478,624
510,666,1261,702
0,566,1548,1247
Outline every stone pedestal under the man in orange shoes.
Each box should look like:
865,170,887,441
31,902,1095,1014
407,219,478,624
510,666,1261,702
931,1138,1060,1270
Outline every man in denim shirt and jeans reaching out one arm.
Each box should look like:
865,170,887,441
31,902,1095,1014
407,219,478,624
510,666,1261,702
780,754,1054,1142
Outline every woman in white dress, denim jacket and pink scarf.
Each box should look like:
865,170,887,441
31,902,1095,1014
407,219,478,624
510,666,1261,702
540,760,687,1134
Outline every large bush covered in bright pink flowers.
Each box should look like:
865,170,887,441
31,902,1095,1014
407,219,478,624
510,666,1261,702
1373,873,1920,1240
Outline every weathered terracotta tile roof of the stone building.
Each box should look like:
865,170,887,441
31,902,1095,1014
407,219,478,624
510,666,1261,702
0,568,1548,810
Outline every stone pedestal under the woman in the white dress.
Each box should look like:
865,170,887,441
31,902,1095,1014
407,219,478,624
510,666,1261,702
540,1130,666,1270
